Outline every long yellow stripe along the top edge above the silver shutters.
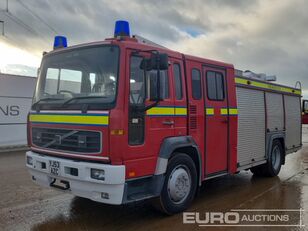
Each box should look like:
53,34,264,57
235,77,302,95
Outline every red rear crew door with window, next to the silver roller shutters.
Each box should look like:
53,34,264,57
203,66,229,177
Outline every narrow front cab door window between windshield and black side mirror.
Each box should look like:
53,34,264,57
129,56,145,105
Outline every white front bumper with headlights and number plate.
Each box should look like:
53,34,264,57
26,151,125,205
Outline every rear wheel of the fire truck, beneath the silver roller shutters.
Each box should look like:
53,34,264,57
250,140,283,177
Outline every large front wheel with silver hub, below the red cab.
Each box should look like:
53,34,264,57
153,153,198,215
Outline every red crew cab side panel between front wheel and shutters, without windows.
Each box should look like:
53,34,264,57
185,56,237,179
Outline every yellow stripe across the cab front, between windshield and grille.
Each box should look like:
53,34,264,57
29,114,109,125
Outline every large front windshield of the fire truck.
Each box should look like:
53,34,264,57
33,45,119,109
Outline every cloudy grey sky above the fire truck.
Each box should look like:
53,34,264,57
0,0,308,98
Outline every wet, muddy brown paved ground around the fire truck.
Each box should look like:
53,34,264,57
0,127,308,231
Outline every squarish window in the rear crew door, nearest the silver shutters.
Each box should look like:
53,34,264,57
206,71,225,100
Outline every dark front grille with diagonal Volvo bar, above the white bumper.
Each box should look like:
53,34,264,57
32,128,101,154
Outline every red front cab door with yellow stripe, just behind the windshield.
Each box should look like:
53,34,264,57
124,50,175,177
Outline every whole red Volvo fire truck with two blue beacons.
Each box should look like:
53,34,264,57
26,21,302,214
